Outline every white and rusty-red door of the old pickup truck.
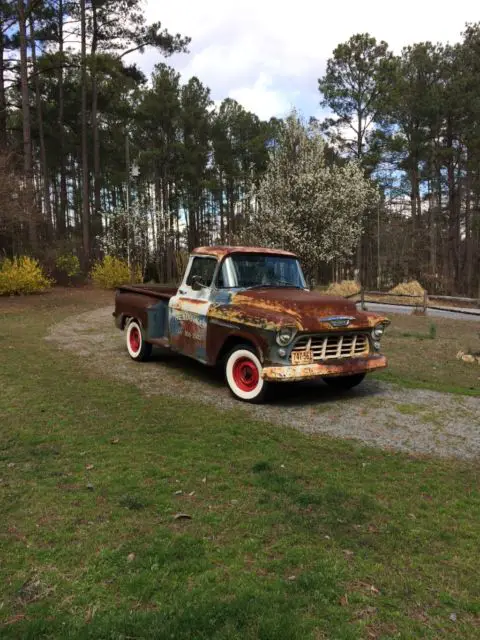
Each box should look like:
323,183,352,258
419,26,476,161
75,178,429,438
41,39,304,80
169,256,217,362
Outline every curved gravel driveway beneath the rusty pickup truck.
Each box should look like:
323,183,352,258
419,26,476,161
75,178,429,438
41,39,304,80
46,306,480,460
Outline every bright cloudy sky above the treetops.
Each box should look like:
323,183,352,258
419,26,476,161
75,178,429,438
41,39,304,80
130,0,480,119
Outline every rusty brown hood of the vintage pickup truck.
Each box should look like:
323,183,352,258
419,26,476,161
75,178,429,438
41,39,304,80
218,287,386,332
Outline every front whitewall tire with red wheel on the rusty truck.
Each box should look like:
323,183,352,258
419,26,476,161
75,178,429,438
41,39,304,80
225,345,267,403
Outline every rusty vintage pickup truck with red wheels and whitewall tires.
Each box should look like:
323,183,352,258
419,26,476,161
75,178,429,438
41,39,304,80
113,246,390,402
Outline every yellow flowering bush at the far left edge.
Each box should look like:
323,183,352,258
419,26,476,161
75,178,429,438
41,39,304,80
0,256,53,295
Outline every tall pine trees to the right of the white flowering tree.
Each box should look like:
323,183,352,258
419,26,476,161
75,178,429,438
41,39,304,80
319,24,480,297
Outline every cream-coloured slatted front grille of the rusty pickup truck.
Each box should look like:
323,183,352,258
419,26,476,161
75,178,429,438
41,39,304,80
292,333,370,360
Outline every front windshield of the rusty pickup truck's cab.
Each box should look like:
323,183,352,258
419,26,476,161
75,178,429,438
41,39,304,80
218,253,306,289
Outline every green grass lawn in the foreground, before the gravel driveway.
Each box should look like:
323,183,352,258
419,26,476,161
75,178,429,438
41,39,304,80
0,292,480,640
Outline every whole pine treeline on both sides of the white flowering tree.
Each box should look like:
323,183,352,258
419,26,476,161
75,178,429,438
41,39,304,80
0,0,480,295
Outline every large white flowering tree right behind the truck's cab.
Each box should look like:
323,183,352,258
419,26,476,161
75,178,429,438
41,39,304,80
245,112,378,274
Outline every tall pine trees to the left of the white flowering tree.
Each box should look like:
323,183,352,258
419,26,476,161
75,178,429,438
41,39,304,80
0,0,275,280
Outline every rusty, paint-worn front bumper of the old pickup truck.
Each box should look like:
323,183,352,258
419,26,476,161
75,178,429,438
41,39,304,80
262,355,387,382
